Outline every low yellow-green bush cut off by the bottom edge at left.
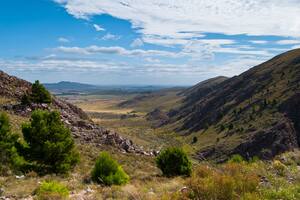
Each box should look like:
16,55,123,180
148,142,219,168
36,181,70,200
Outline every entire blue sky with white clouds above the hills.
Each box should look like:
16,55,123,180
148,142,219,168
0,0,300,86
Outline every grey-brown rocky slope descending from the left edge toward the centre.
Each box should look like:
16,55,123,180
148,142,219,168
0,71,156,155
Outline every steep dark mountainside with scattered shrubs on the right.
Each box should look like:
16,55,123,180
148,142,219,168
168,49,300,159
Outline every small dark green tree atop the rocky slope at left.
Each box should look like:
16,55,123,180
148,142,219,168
21,80,52,105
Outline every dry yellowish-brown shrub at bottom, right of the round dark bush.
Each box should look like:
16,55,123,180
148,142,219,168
187,163,259,200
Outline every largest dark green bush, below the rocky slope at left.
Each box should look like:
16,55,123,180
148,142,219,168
22,110,79,173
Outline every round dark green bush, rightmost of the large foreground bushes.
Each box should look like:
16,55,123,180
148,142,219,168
156,147,192,176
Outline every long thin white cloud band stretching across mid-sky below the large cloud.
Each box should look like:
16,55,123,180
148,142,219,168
54,40,272,60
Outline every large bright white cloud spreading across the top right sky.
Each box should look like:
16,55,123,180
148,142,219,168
56,0,300,45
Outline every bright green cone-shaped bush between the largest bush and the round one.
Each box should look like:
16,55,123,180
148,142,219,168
92,152,129,185
